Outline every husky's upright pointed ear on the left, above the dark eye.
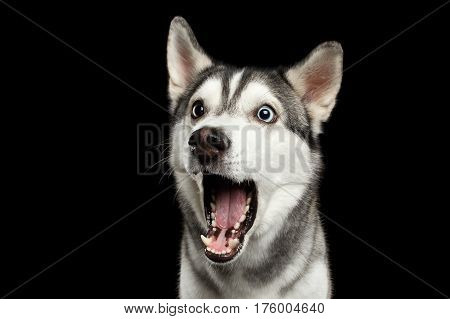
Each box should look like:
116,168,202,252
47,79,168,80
167,17,212,104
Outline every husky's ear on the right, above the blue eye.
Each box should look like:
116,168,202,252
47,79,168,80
286,42,343,134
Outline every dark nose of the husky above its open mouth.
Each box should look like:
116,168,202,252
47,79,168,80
188,127,230,163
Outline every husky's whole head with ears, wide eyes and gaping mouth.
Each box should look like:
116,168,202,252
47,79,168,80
167,17,342,263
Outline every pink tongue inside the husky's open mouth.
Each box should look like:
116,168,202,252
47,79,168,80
216,186,247,229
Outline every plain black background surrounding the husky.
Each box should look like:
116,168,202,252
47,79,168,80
0,0,450,298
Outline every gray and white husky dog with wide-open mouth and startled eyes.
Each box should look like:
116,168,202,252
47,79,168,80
167,17,343,298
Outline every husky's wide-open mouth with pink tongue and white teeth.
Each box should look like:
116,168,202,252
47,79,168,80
201,175,258,262
